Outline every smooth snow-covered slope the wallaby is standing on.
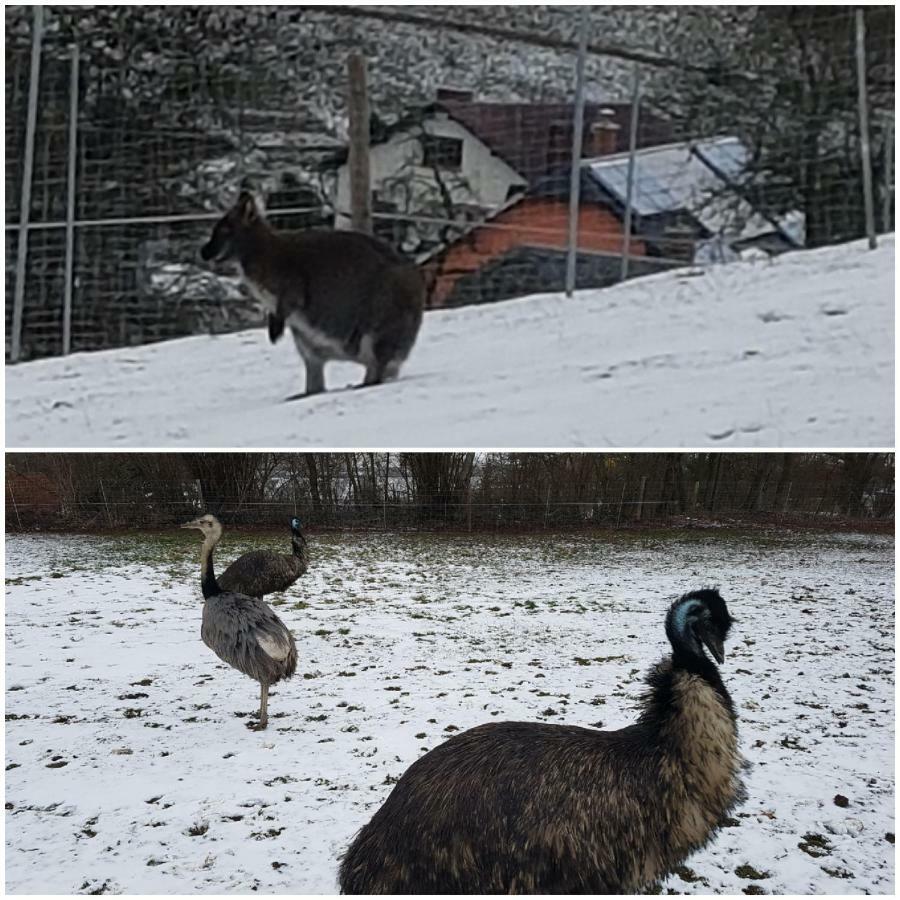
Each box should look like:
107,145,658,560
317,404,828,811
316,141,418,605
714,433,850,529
6,237,894,448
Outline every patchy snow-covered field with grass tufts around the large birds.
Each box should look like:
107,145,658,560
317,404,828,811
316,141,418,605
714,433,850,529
6,530,894,894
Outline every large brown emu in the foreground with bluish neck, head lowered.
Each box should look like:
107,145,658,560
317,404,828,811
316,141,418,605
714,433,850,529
340,590,744,894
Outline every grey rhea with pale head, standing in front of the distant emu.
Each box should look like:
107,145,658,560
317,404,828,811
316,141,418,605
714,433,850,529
181,515,297,730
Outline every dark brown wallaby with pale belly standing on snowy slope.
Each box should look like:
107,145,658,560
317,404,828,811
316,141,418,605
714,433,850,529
200,191,425,399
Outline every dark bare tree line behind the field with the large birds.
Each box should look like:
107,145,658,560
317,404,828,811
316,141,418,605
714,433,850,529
6,453,894,530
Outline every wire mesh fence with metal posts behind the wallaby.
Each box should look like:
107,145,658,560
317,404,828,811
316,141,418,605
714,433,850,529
5,6,894,361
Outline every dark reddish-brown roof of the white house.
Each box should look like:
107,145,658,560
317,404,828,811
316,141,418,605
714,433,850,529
330,99,672,185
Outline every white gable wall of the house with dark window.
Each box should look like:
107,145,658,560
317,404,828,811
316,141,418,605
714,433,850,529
335,115,525,228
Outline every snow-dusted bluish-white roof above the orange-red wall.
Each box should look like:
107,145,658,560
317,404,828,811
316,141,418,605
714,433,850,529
587,137,794,240
